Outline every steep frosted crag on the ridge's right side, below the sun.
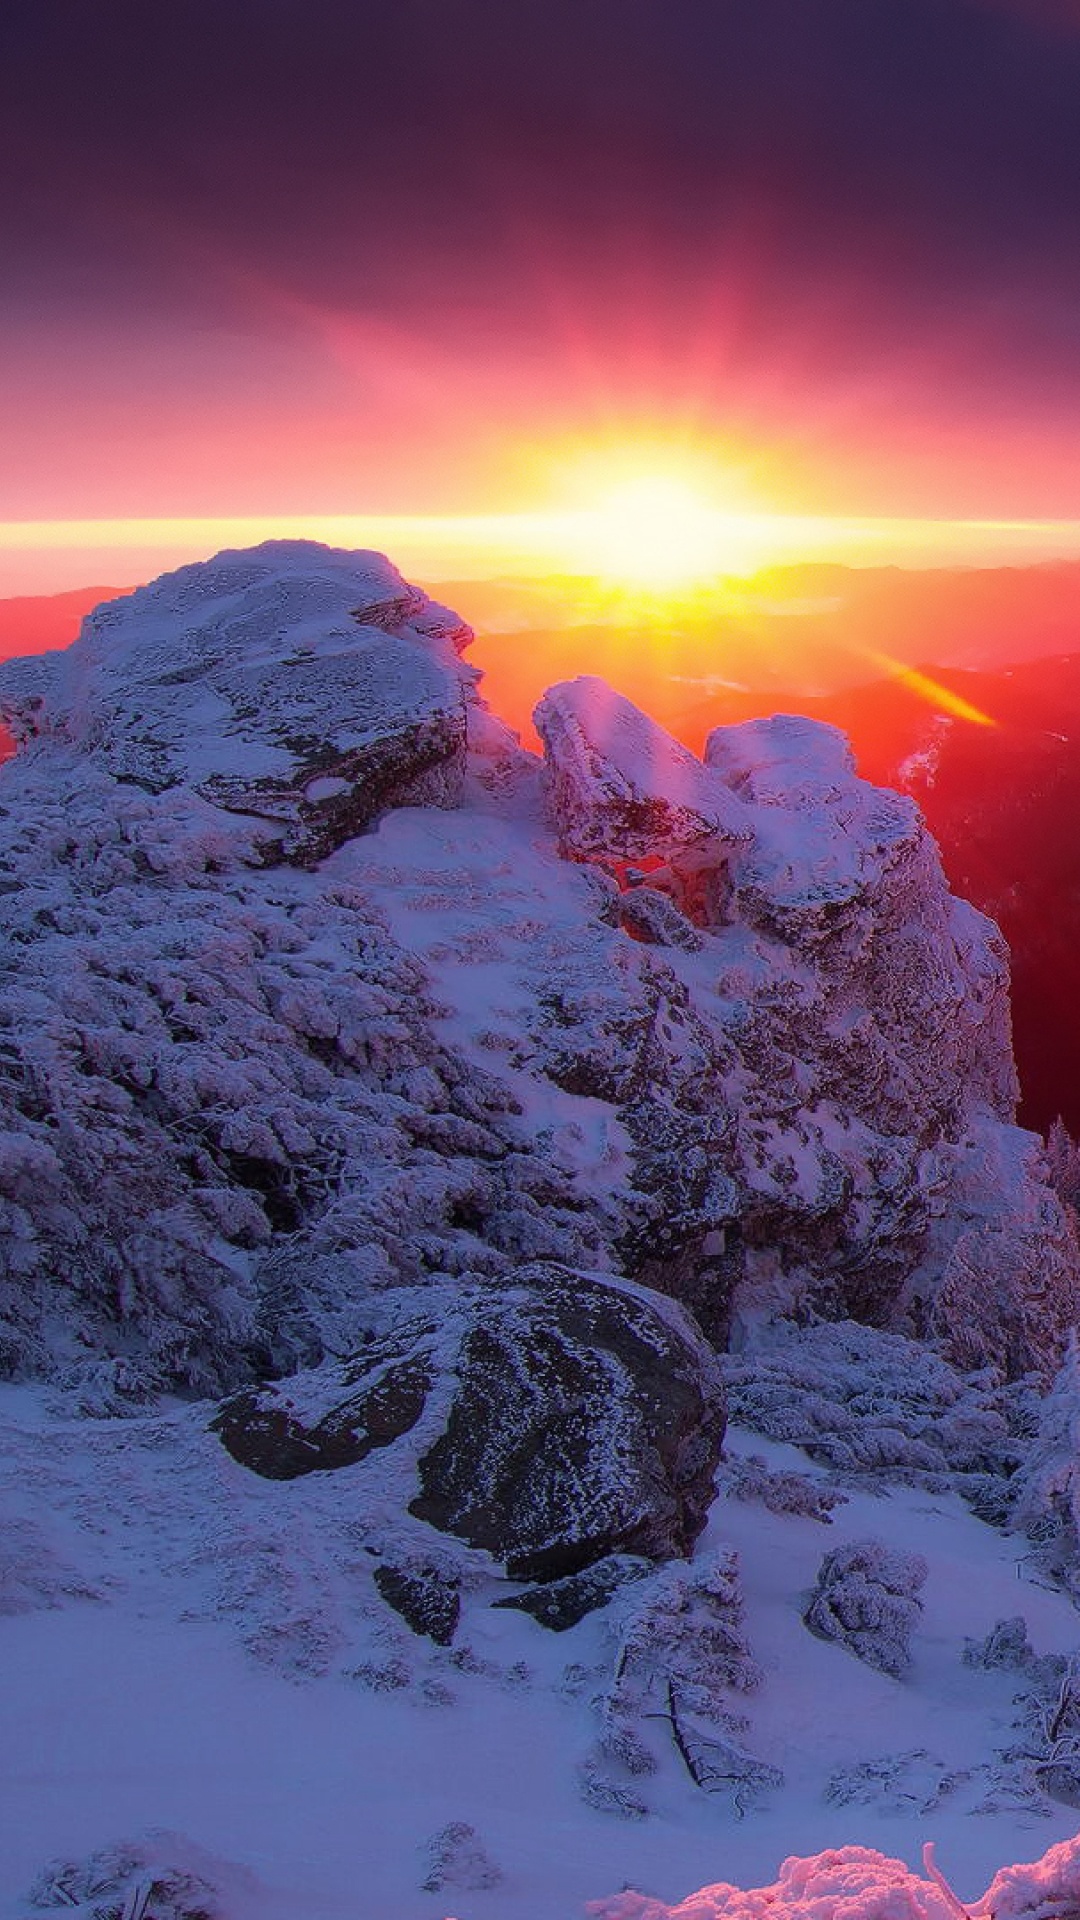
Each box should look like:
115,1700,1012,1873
536,680,1078,1371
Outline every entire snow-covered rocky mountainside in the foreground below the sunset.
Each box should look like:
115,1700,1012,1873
0,543,1080,1920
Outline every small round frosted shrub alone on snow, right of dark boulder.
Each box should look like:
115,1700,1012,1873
803,1540,928,1678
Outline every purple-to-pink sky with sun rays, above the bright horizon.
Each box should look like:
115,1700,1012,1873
0,0,1080,591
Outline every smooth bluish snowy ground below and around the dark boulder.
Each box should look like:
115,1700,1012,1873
0,1388,1080,1920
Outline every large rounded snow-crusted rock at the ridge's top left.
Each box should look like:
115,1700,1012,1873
0,541,473,864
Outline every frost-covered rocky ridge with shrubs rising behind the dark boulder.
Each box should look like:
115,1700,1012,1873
0,543,1080,1397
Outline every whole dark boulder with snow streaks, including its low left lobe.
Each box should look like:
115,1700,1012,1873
215,1267,724,1574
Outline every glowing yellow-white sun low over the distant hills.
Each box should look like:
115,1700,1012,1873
577,476,726,591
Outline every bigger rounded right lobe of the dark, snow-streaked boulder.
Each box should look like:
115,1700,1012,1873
409,1267,724,1580
